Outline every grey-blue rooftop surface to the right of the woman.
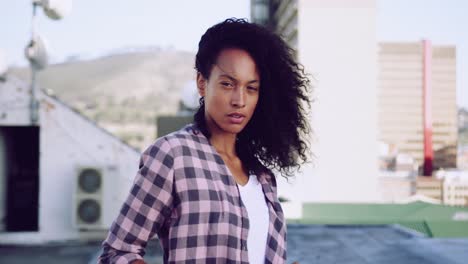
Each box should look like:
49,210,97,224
288,225,468,264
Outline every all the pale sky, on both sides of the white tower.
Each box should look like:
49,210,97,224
0,0,468,108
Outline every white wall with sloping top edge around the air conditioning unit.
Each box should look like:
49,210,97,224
0,78,139,244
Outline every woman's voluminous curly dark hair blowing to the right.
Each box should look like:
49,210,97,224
194,18,310,177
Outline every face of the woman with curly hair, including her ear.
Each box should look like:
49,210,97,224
197,48,260,137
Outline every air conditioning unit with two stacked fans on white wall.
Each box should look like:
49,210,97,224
73,167,104,230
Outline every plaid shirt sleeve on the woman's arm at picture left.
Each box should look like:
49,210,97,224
98,138,174,263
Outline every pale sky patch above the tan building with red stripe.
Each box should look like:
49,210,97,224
377,0,468,109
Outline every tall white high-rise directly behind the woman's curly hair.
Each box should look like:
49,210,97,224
251,0,380,202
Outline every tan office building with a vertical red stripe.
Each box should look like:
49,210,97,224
378,41,457,169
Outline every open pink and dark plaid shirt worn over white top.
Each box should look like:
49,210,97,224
99,125,286,264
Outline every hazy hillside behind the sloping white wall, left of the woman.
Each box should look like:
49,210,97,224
11,50,195,149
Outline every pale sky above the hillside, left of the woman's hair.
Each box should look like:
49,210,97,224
0,0,250,65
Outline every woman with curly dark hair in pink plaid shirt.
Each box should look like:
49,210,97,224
100,19,309,263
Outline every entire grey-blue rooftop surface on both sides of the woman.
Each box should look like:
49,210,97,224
0,224,468,264
